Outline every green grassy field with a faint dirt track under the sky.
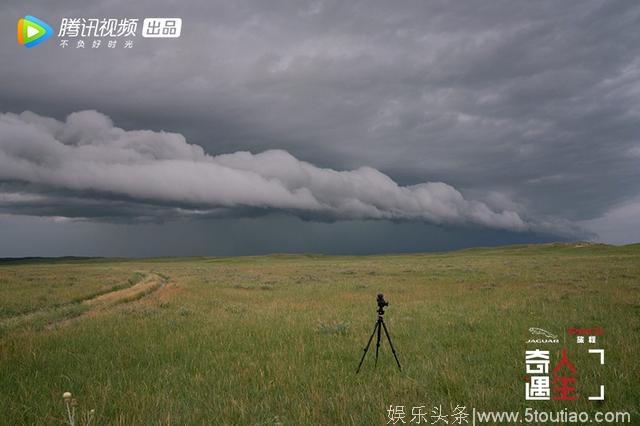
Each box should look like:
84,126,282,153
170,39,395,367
0,244,640,425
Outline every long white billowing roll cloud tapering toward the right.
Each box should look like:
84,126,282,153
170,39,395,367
0,111,570,232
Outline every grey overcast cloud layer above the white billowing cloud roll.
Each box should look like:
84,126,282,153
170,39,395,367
0,0,640,246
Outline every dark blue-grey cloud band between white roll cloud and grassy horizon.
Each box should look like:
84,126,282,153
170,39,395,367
0,214,557,257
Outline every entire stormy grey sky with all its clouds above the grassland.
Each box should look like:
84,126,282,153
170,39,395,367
0,0,640,257
